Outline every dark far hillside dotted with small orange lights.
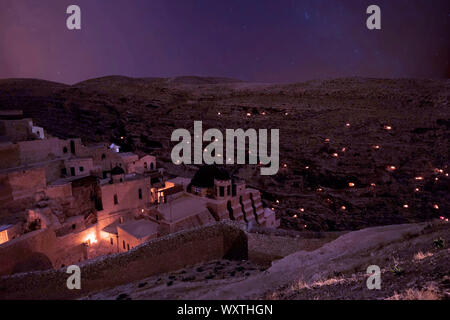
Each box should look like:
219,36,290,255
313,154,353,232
0,76,450,231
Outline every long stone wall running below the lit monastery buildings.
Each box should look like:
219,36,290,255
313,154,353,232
0,221,248,299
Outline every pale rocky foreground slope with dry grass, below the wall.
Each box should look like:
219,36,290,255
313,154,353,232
84,222,450,300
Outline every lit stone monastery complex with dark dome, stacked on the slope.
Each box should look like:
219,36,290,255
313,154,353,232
0,112,279,275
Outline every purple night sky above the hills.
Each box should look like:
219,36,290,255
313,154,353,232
0,0,450,84
